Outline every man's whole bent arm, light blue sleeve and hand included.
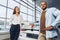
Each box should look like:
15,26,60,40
44,9,60,30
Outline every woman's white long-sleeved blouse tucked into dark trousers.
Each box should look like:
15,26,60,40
9,14,24,25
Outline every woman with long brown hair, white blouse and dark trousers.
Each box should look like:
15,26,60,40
10,6,24,40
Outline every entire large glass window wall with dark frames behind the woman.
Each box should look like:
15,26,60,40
0,0,40,29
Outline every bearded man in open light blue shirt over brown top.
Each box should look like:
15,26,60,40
38,1,60,40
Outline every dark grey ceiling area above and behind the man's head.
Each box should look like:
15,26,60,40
36,0,60,9
